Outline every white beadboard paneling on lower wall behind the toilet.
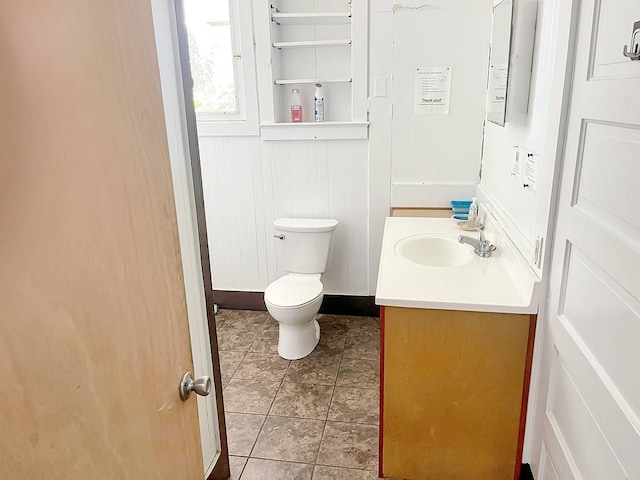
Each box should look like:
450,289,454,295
199,136,369,295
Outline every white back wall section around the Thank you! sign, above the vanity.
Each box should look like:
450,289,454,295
389,0,492,207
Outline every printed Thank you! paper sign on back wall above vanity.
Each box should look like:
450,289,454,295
414,67,451,115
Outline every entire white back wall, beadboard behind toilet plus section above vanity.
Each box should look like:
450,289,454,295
199,0,491,295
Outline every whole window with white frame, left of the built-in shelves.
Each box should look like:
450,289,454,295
183,0,258,135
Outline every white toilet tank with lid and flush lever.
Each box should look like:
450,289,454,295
273,218,338,273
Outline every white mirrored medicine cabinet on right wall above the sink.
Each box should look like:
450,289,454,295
487,0,538,126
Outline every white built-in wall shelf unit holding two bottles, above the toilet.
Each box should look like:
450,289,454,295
254,0,368,140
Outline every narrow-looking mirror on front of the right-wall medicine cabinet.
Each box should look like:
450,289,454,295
487,0,513,127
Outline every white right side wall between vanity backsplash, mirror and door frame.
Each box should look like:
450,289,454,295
479,0,568,273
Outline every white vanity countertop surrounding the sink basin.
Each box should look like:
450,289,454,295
376,215,541,314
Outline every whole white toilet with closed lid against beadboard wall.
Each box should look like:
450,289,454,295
264,218,338,360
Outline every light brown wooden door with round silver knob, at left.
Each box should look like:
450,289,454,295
0,0,203,480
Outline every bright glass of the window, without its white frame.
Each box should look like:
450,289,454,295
184,0,238,114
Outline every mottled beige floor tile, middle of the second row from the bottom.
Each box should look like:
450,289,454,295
251,416,324,463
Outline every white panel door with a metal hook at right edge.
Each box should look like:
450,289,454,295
538,0,640,480
